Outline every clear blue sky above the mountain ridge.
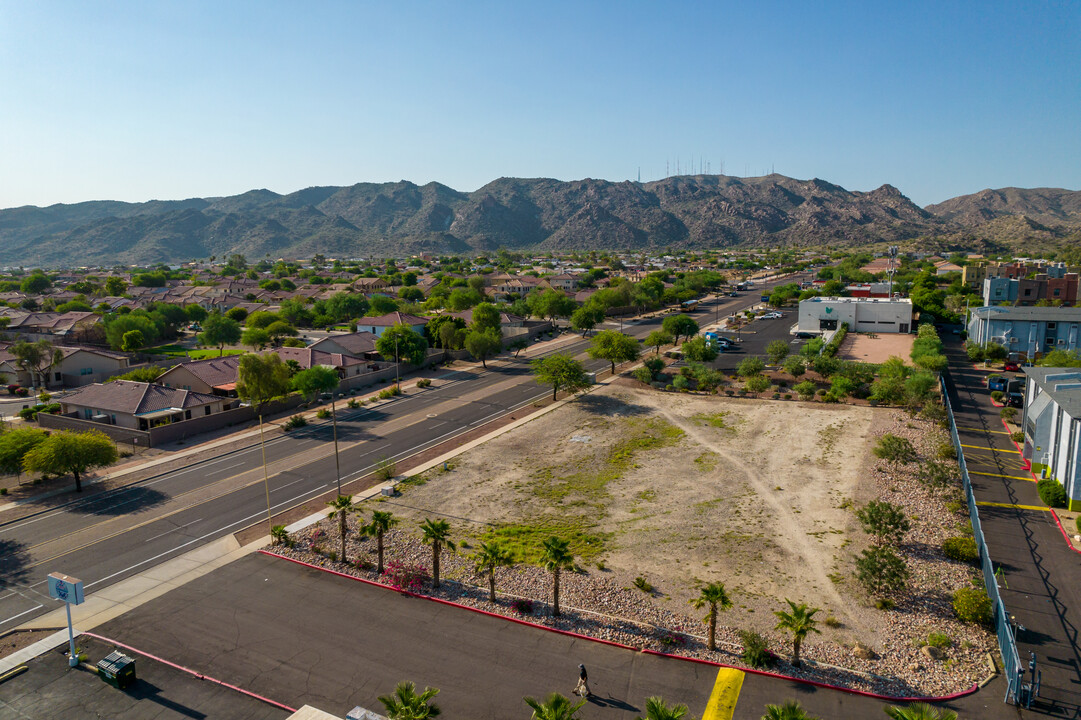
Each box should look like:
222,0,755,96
0,0,1081,208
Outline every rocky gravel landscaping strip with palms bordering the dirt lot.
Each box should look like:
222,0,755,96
278,399,997,696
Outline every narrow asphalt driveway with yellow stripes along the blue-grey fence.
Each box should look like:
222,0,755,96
946,337,1081,718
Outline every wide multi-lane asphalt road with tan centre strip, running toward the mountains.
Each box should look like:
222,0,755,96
0,272,808,632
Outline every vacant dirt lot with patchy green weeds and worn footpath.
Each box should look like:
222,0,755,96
376,387,877,642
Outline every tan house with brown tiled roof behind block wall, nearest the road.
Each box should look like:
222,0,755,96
61,381,228,430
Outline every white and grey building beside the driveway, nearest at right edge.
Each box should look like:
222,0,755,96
1022,368,1081,510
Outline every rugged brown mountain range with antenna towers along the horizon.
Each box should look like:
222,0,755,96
0,174,1081,267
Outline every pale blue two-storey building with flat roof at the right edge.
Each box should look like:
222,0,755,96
969,306,1081,360
